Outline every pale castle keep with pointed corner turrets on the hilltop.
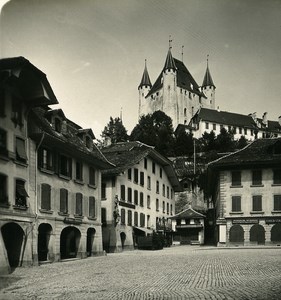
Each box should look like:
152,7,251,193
138,47,213,129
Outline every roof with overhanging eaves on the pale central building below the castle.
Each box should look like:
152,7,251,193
101,141,181,192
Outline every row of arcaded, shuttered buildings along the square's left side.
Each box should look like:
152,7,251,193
0,57,112,273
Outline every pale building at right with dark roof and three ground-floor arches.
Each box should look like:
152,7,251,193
208,138,281,246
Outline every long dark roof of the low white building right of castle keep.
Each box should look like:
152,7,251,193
191,108,256,129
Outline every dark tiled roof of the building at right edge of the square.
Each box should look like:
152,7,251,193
208,138,281,169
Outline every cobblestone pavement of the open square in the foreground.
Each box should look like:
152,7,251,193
0,246,281,300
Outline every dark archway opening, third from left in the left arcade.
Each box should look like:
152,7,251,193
60,226,81,259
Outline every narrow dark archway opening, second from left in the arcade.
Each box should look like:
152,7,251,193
37,223,53,261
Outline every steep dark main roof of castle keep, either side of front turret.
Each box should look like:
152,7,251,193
146,57,203,98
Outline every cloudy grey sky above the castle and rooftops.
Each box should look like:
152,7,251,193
0,0,281,138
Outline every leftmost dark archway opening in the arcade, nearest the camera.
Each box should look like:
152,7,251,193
1,222,24,268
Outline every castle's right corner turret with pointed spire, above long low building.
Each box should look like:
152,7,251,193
201,55,216,109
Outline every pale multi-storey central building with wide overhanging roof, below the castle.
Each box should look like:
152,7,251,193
99,142,180,252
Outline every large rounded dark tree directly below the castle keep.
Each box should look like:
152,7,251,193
130,110,175,156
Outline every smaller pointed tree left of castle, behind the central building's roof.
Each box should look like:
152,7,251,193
101,117,128,143
